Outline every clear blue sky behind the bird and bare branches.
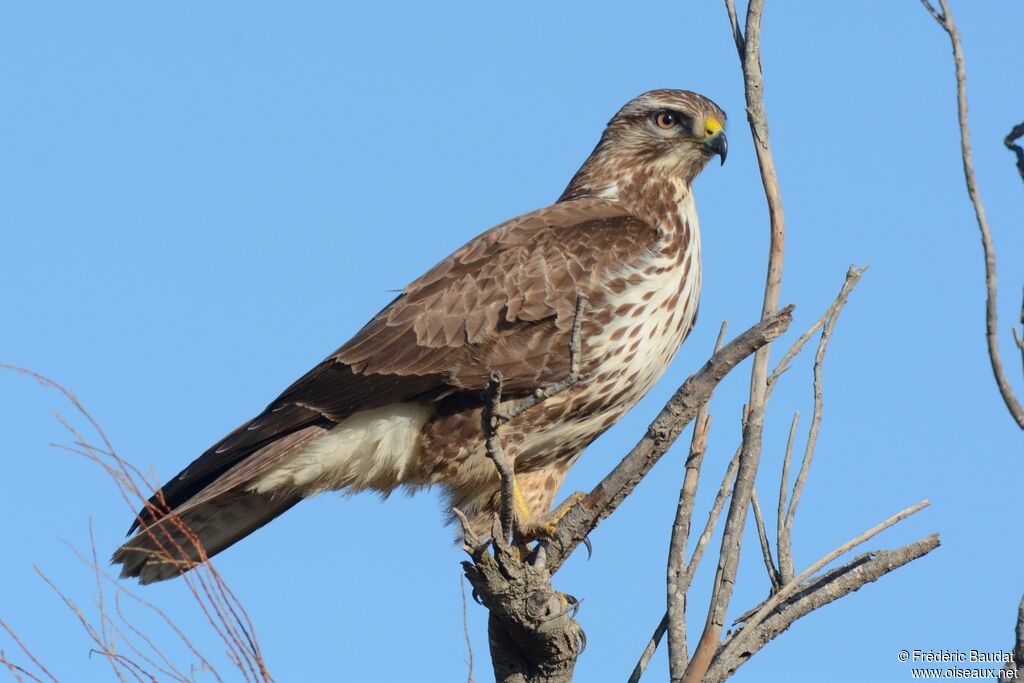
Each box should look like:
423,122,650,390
0,0,1024,681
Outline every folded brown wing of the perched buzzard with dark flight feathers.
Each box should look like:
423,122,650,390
133,199,656,528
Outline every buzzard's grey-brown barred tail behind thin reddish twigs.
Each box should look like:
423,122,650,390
112,488,302,584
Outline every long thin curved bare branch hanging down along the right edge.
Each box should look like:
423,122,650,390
921,0,1024,429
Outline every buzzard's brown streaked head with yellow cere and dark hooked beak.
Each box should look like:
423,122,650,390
562,90,729,200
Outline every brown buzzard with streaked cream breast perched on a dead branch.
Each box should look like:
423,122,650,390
114,90,727,584
